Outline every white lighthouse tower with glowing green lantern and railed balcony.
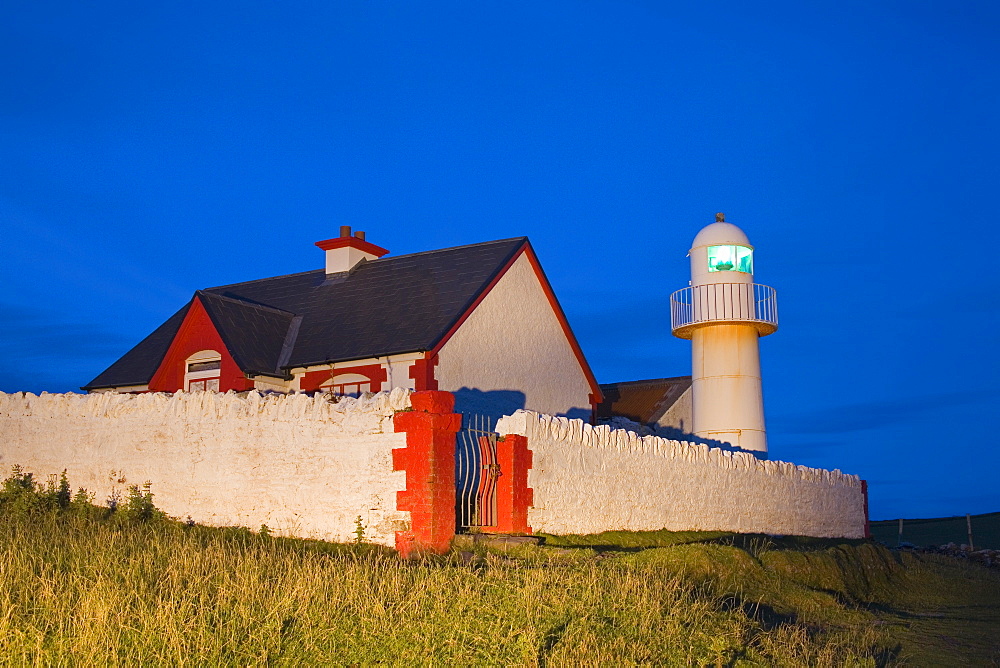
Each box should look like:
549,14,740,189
670,213,778,456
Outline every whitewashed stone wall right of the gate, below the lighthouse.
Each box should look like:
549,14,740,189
497,411,865,538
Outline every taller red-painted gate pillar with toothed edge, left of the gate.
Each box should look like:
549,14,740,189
392,391,462,558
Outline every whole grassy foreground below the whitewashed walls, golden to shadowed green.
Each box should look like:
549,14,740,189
0,470,1000,666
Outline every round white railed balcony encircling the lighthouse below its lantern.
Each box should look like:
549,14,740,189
670,283,778,339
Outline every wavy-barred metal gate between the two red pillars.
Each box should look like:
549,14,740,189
455,414,500,530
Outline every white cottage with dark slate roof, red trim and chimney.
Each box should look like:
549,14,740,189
82,226,601,418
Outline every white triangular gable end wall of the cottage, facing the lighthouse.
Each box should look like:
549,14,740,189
434,254,591,417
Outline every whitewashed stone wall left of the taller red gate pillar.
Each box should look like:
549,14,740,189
0,389,410,546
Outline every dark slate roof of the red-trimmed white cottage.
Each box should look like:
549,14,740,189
82,237,528,390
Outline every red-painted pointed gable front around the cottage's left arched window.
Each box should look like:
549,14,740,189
149,297,253,392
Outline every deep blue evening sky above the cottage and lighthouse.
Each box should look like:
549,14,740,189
0,1,1000,519
